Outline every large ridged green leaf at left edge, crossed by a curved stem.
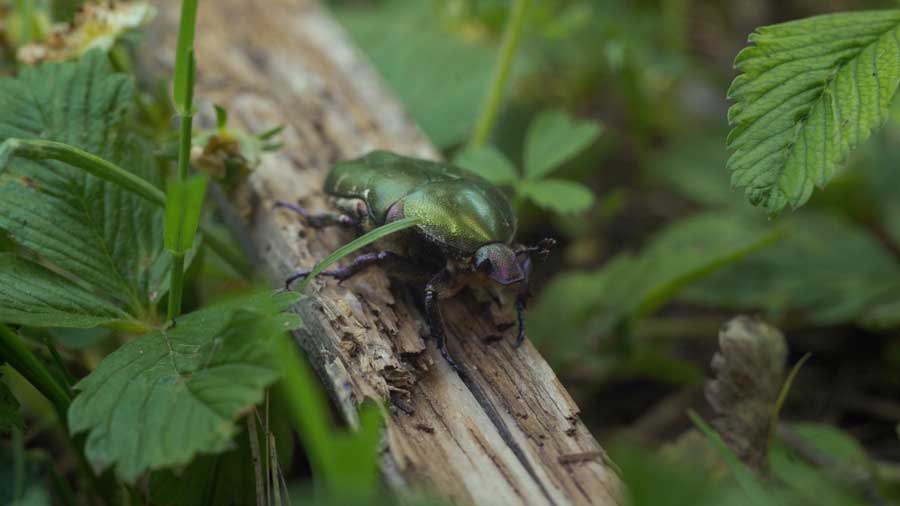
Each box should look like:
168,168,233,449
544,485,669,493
0,51,169,315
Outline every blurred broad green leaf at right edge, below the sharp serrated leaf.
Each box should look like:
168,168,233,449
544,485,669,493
681,212,900,325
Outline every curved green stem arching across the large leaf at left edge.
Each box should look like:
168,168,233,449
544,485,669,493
0,139,249,275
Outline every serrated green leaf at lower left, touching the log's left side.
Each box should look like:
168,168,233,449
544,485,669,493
69,293,297,483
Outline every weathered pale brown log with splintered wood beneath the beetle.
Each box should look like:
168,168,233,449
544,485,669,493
145,0,621,506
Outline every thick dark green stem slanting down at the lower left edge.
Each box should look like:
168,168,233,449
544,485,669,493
0,323,72,423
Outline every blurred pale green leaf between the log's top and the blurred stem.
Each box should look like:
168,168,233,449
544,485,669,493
335,0,506,147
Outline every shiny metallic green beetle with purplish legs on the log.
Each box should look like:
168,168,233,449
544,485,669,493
276,151,554,368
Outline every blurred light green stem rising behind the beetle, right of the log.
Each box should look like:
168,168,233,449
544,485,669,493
470,0,530,146
